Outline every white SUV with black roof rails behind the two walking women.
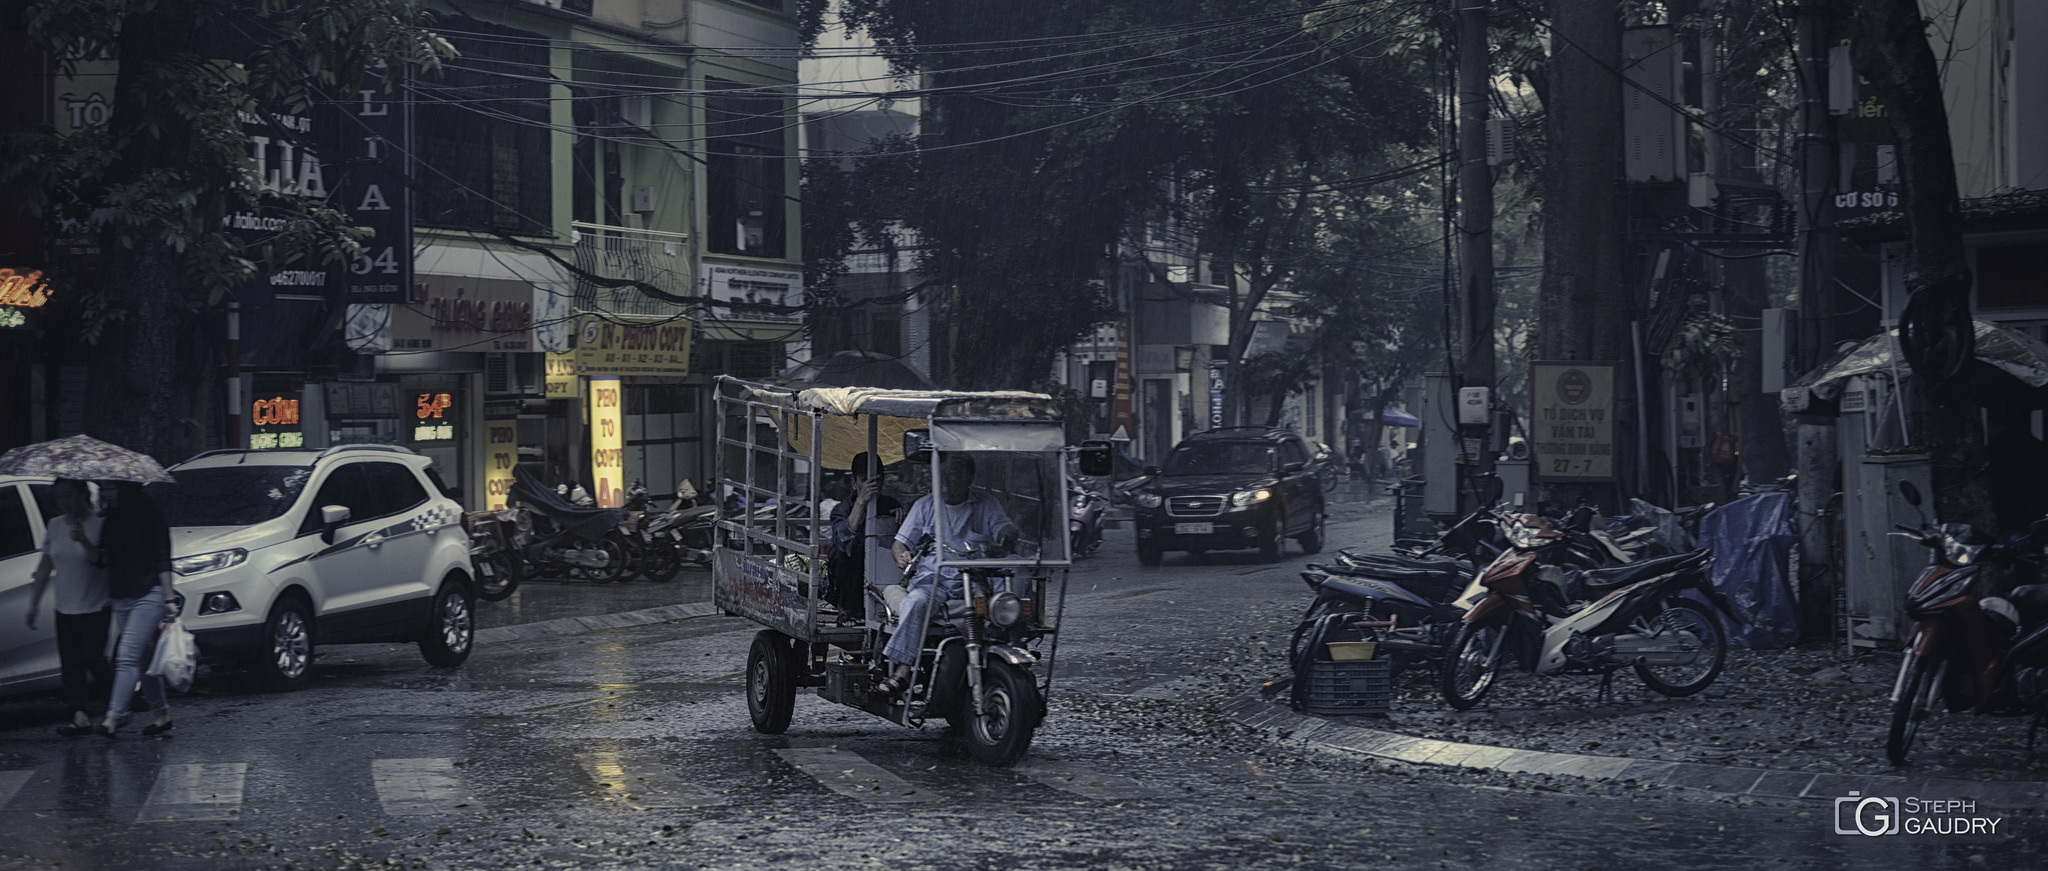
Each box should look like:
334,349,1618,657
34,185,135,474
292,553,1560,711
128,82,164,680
152,445,477,689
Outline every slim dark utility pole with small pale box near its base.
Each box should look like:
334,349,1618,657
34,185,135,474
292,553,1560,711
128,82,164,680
1456,0,1495,502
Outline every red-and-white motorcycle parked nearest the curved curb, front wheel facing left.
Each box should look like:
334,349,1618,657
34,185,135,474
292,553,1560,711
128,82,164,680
1440,512,1729,711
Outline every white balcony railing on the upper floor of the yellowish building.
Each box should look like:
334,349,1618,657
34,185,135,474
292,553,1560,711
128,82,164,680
569,221,698,318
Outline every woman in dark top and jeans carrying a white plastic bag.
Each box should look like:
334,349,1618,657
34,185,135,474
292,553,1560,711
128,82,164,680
98,482,182,738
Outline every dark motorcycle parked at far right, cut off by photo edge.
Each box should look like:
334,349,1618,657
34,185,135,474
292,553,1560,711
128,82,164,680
1884,482,2048,764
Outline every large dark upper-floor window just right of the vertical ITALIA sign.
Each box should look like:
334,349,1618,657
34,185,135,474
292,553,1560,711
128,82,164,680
414,18,553,236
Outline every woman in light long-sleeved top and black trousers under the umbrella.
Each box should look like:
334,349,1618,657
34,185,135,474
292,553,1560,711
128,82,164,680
29,480,113,738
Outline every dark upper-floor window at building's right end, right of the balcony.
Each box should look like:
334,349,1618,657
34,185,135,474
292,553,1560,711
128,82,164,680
705,78,791,258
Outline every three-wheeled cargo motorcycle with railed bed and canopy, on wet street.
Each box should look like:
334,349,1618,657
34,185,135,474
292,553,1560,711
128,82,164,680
713,377,1110,764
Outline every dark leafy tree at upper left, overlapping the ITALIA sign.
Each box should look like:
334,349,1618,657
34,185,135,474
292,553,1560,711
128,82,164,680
0,0,451,459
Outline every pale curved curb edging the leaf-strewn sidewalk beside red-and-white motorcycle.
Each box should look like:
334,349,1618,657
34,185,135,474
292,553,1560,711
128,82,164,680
1223,685,2048,810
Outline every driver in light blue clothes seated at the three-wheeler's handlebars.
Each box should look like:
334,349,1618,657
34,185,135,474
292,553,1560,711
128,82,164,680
874,453,1018,695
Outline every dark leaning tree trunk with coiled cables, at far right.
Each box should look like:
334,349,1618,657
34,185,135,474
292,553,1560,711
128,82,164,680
1849,0,1995,529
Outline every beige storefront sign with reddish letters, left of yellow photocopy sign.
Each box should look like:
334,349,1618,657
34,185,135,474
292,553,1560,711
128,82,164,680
391,275,535,350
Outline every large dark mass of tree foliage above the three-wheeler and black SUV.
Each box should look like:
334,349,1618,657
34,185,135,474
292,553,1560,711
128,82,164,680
813,0,1432,387
